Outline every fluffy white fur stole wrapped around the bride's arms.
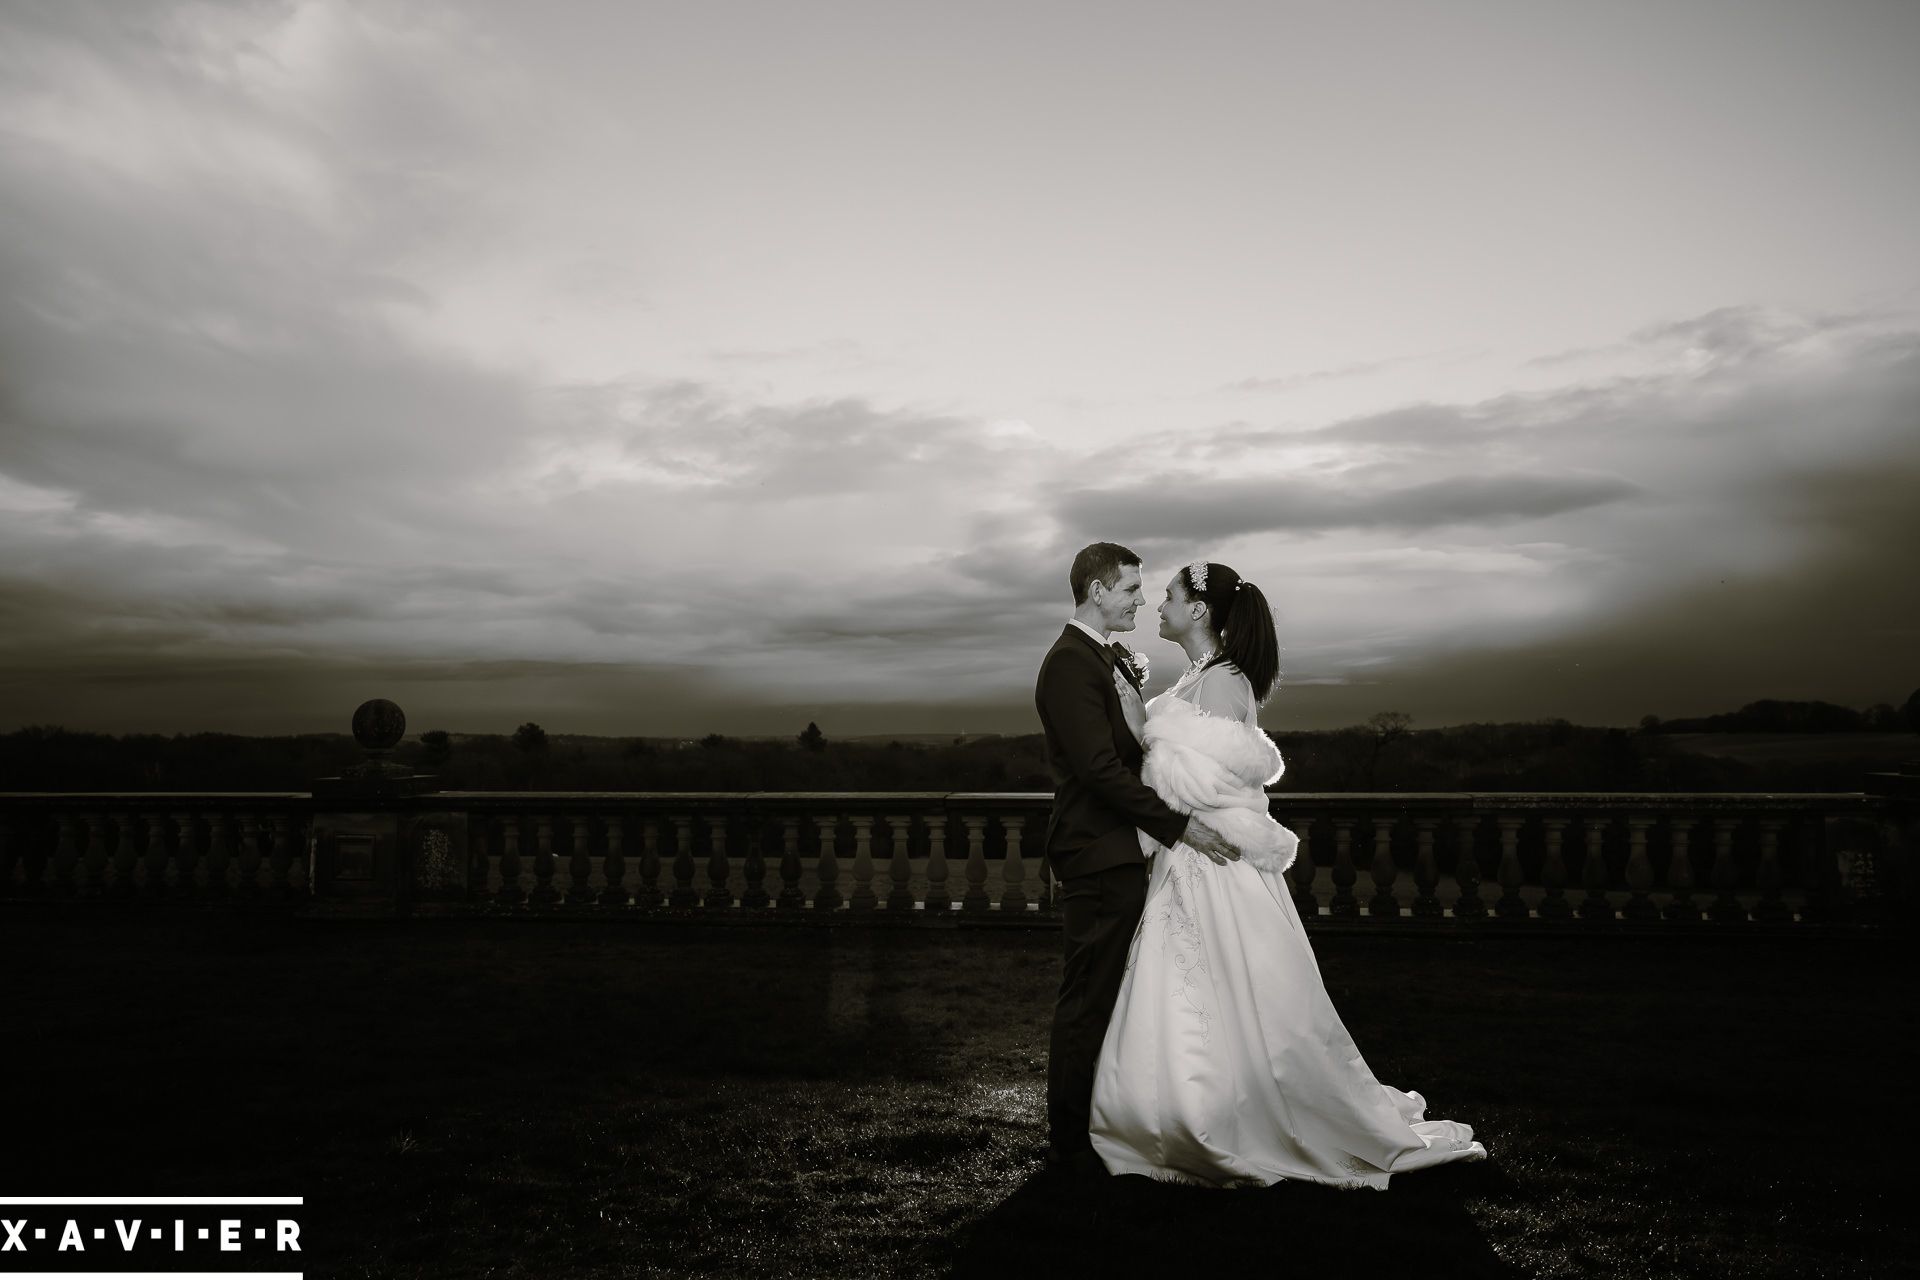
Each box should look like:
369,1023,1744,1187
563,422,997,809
1140,697,1300,873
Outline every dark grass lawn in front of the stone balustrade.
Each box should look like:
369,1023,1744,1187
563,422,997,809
0,908,1920,1280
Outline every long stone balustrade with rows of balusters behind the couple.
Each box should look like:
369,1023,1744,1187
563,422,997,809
0,793,1887,931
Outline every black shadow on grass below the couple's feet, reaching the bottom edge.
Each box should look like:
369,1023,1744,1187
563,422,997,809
947,1161,1524,1280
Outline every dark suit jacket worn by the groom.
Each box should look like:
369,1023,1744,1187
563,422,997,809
1033,626,1187,879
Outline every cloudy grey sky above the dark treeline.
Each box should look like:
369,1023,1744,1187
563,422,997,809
0,0,1920,737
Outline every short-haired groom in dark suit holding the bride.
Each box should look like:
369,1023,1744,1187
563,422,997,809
1033,543,1238,1174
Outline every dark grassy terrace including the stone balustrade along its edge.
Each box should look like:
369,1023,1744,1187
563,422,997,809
0,706,1916,1276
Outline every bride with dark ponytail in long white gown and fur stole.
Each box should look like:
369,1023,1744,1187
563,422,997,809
1092,560,1486,1190
